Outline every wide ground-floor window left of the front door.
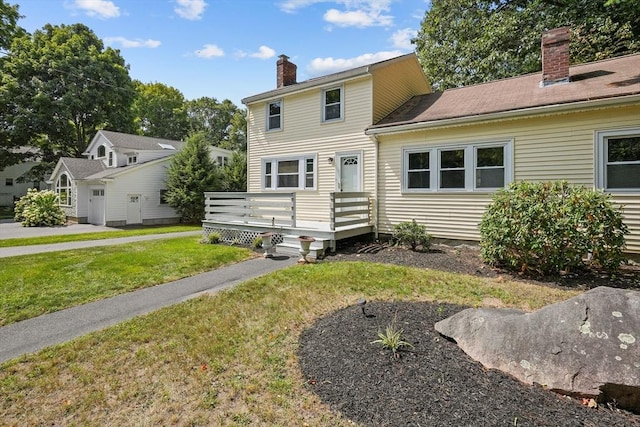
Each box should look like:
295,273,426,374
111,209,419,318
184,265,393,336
262,155,316,190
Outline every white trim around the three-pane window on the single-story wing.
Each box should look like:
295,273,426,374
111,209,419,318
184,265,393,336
401,139,513,193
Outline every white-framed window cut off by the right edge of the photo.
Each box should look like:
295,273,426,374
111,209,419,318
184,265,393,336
596,129,640,191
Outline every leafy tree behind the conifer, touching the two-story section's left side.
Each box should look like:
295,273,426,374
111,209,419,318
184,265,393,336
187,97,247,150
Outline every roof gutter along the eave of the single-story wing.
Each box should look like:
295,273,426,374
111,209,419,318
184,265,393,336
365,94,640,135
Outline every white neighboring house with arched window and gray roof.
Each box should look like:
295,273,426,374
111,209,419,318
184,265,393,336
47,130,231,227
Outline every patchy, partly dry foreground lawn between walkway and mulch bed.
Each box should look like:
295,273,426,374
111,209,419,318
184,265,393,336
0,258,577,427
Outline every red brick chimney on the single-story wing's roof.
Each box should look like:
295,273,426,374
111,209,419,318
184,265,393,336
541,27,569,86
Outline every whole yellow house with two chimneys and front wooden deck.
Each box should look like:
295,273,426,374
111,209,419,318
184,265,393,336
204,28,640,254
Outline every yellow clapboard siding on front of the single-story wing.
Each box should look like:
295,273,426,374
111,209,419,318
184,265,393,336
378,105,640,252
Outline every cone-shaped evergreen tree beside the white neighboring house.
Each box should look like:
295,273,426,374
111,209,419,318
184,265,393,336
166,133,220,222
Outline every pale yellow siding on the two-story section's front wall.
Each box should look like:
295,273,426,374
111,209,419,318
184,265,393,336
248,76,375,222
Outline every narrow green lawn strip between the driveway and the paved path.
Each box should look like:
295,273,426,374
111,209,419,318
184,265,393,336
0,225,202,248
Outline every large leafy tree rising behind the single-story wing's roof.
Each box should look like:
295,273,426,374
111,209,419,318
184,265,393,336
414,0,640,90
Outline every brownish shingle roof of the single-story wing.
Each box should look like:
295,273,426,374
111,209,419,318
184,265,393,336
369,54,640,132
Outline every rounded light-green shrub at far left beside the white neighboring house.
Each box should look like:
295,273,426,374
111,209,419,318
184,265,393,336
14,188,67,227
